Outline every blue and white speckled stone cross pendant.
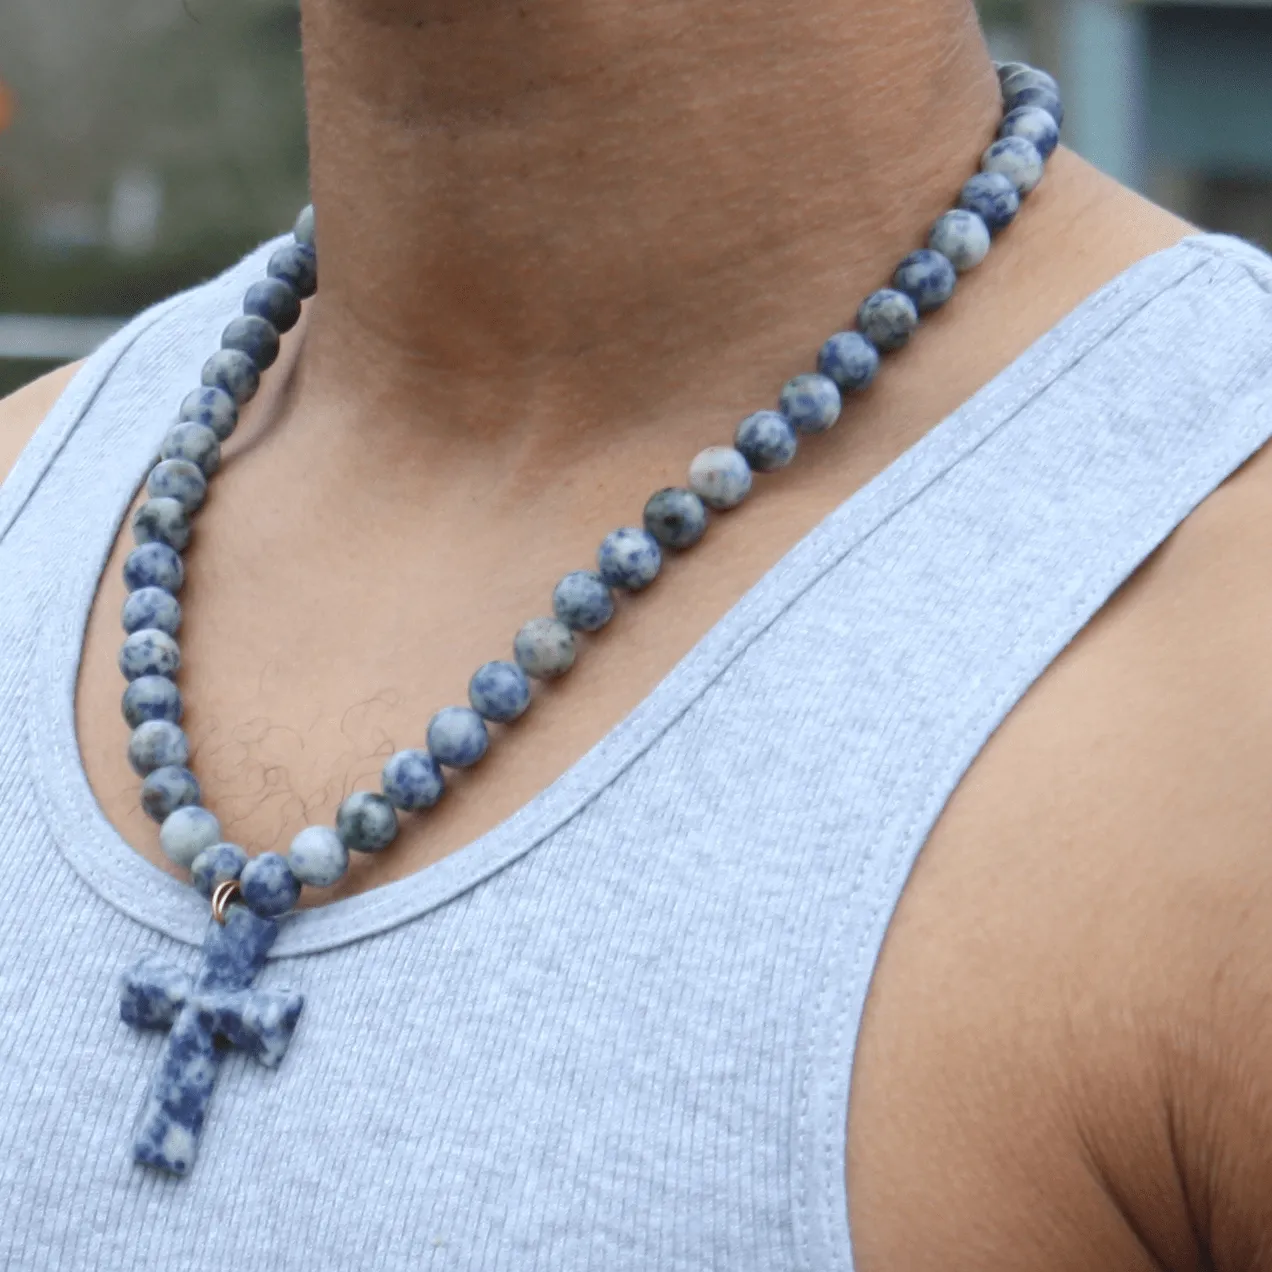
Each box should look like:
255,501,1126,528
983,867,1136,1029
120,906,305,1175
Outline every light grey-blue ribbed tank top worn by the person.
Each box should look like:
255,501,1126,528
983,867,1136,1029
0,237,1272,1272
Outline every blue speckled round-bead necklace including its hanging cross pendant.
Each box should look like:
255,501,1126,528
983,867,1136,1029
120,62,1063,1175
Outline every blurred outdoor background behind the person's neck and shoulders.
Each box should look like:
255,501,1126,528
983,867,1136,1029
0,0,1272,396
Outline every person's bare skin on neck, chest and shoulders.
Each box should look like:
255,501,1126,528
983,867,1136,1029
0,0,1272,1272
